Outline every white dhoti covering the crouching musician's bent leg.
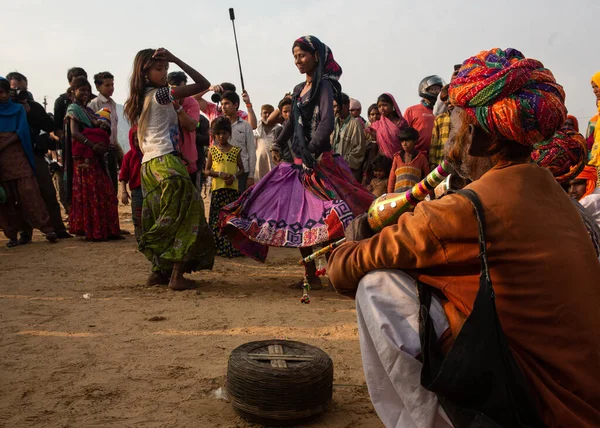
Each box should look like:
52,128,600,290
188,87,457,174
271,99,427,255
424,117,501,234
356,269,452,428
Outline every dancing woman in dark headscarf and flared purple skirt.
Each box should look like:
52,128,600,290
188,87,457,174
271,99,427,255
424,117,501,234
221,36,373,289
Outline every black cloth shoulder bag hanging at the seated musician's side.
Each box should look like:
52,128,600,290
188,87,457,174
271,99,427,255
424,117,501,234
417,190,544,428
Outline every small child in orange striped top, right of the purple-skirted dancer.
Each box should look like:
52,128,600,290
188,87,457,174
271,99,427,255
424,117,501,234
388,128,430,193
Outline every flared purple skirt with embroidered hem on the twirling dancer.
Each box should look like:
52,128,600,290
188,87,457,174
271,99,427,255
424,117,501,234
220,153,374,262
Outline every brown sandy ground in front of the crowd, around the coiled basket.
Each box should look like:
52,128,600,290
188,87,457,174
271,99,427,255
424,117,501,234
0,201,382,428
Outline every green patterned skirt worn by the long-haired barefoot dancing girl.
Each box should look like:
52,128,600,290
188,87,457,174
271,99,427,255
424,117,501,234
139,154,215,273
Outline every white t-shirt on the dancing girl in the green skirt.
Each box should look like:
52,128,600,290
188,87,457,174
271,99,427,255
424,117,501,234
140,87,179,163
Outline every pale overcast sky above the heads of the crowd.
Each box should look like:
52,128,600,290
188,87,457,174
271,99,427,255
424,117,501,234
0,0,600,126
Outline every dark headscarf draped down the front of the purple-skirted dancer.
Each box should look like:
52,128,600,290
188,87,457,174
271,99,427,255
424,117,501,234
292,36,342,168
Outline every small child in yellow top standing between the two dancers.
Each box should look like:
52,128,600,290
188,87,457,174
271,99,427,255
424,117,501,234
205,116,244,257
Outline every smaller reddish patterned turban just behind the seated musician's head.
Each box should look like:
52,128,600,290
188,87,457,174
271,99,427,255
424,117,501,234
531,128,587,184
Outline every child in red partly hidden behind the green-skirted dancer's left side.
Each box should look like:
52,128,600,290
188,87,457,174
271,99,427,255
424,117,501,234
119,125,144,241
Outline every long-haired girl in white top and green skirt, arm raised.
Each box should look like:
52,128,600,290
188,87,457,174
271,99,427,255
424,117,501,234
125,48,215,290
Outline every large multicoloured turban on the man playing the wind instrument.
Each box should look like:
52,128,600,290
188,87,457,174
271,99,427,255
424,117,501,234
449,48,567,146
